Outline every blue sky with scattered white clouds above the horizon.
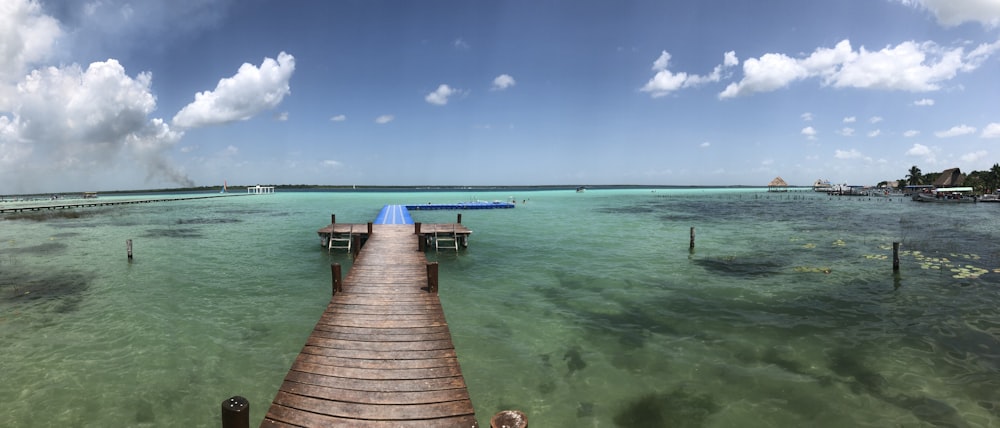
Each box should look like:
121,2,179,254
0,0,1000,194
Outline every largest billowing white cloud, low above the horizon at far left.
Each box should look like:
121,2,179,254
0,59,192,190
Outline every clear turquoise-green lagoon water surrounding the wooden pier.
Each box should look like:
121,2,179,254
0,189,1000,427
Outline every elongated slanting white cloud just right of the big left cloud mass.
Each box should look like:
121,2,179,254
173,52,295,128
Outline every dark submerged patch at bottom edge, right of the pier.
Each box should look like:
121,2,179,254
614,389,719,428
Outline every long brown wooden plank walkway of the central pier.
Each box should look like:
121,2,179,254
261,224,478,428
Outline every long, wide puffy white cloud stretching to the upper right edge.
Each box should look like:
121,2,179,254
719,40,1000,99
